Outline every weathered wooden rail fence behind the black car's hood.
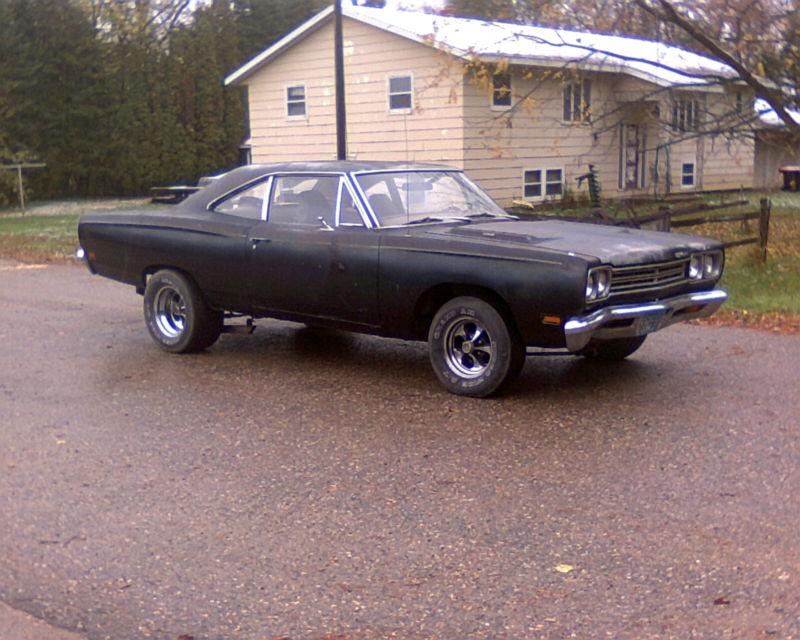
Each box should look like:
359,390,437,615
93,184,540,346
509,198,772,261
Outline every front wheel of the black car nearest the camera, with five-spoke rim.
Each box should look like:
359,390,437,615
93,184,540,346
428,297,525,398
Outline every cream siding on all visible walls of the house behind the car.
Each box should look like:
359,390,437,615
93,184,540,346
245,18,754,205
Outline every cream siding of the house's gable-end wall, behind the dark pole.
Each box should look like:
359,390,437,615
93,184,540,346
247,19,464,167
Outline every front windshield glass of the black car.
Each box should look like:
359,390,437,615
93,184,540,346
356,171,507,227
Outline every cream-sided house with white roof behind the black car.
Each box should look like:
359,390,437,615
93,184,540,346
225,6,753,204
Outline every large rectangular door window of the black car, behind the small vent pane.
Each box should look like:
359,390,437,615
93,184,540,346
269,175,339,227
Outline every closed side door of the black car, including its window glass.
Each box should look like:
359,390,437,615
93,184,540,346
248,174,378,325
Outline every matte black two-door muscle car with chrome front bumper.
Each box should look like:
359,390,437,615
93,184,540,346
78,162,727,397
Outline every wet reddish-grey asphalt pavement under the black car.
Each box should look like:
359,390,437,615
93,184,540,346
0,262,800,640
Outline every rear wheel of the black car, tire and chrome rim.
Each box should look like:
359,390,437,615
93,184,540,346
144,269,223,353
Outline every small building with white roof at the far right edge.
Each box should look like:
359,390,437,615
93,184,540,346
753,100,800,189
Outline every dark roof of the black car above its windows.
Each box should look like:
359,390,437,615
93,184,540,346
186,160,460,206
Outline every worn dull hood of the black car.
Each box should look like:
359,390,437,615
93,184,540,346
425,220,721,266
